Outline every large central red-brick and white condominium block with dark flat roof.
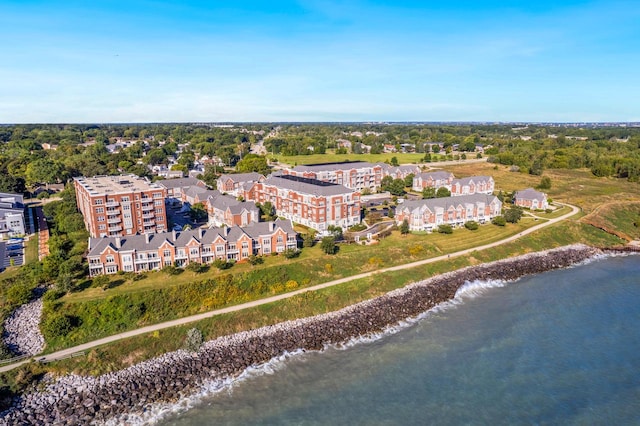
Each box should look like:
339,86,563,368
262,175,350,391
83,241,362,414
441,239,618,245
247,174,360,232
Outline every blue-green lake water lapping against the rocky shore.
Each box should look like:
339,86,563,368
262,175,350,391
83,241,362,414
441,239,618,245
160,256,640,425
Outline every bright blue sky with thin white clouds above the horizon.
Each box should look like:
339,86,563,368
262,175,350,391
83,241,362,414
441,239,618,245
0,0,640,123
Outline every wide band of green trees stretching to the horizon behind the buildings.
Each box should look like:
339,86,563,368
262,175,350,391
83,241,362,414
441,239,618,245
0,123,640,192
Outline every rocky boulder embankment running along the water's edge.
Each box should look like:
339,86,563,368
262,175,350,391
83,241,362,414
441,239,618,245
0,245,637,425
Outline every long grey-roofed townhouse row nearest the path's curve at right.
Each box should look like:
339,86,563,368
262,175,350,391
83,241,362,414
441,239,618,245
395,194,502,231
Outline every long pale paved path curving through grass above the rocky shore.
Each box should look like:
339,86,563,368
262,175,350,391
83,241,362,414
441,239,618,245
0,203,579,372
